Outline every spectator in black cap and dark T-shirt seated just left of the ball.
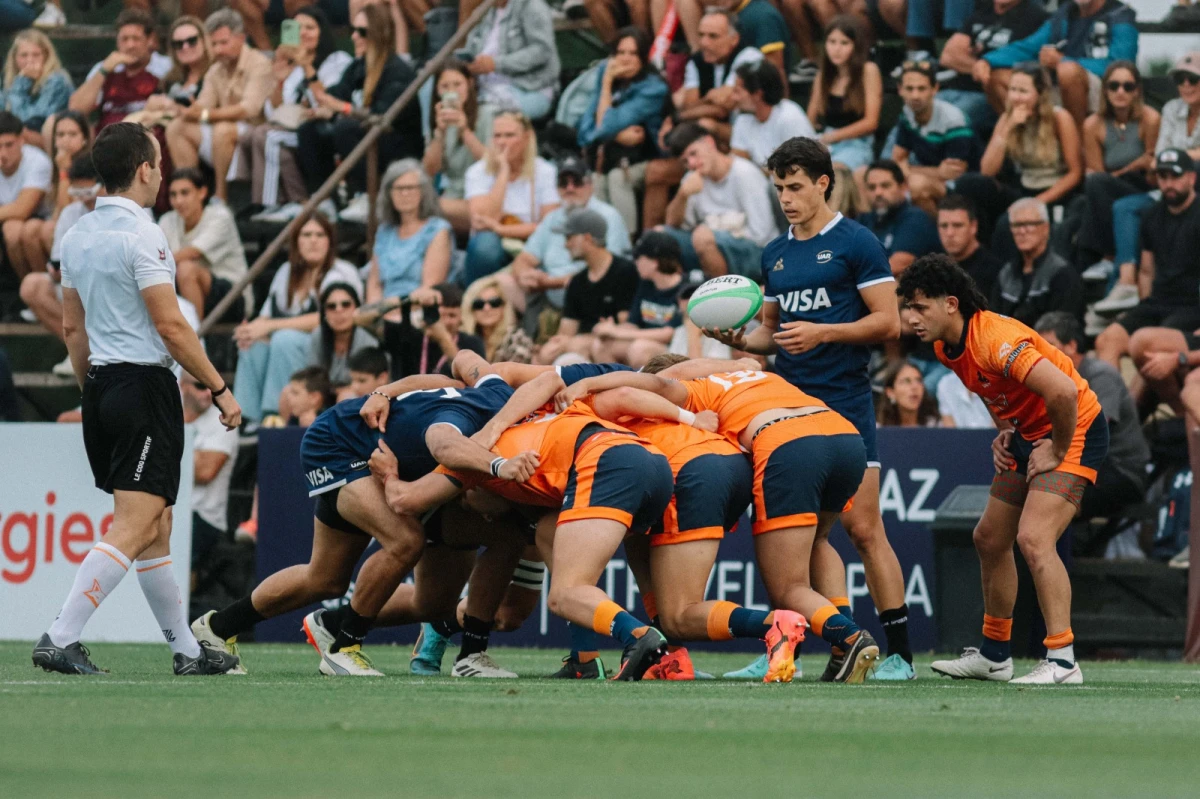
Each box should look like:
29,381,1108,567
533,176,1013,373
592,230,683,370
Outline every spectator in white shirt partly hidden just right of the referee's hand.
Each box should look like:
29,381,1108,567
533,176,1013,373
179,374,238,572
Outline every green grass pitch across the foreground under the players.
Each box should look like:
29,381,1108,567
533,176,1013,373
0,643,1200,799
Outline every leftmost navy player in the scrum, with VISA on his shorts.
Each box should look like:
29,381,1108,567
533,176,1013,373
192,376,552,677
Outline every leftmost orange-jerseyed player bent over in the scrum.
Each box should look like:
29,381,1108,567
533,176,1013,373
372,359,692,680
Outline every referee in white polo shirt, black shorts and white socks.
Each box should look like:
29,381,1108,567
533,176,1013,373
34,122,241,674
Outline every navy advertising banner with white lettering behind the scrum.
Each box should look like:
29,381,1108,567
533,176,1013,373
257,428,995,651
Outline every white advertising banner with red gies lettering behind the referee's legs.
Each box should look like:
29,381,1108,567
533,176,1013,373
0,423,194,643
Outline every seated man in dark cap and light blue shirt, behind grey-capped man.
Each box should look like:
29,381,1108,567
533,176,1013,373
497,156,632,321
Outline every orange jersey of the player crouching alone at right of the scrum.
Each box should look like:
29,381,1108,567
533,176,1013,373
934,311,1100,441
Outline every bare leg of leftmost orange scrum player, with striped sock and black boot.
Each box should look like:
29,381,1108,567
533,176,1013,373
547,518,666,680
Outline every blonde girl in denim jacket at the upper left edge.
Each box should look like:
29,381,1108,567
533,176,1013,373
0,28,74,149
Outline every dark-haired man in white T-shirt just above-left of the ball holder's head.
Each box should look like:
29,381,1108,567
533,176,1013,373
730,60,817,170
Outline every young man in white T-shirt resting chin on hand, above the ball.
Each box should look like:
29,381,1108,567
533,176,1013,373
664,122,779,280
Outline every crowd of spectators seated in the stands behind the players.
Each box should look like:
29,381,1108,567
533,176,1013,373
0,0,1200,563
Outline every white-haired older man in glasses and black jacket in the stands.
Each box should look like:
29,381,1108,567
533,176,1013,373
989,197,1084,328
